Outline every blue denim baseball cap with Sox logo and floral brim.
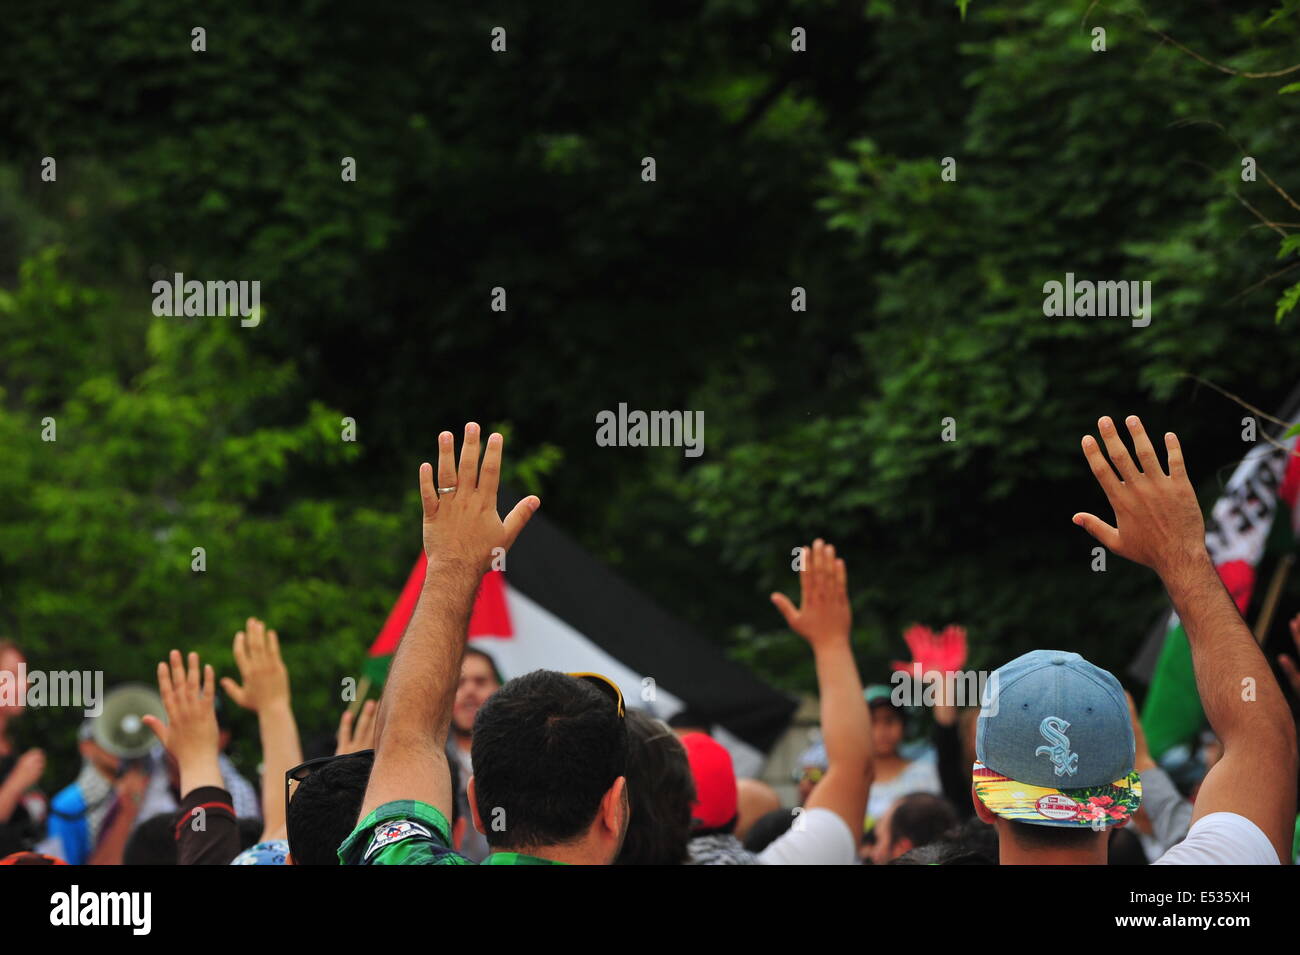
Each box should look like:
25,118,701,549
972,650,1141,830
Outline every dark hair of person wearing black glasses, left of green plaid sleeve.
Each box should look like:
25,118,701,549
285,750,374,865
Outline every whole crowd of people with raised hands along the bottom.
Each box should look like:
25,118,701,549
0,417,1300,865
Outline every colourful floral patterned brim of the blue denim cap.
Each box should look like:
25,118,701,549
971,761,1141,830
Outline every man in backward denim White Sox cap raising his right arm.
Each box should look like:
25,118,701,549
971,416,1296,865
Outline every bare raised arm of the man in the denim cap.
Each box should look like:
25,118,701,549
1074,416,1296,860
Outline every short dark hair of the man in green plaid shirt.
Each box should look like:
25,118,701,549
469,670,628,850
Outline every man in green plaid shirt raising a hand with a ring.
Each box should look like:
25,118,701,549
338,422,642,865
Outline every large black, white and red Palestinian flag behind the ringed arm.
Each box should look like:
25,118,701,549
365,508,797,776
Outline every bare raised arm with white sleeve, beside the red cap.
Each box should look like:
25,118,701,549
772,539,874,839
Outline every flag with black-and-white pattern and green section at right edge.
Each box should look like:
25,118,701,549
1138,394,1300,759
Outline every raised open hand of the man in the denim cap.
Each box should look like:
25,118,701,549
1073,416,1208,578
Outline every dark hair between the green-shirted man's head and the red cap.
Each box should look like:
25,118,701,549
614,709,696,865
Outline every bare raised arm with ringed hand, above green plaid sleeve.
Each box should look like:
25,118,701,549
359,422,541,819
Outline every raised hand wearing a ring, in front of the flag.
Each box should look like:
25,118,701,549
420,421,542,577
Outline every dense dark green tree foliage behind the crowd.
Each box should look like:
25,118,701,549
0,0,1300,779
